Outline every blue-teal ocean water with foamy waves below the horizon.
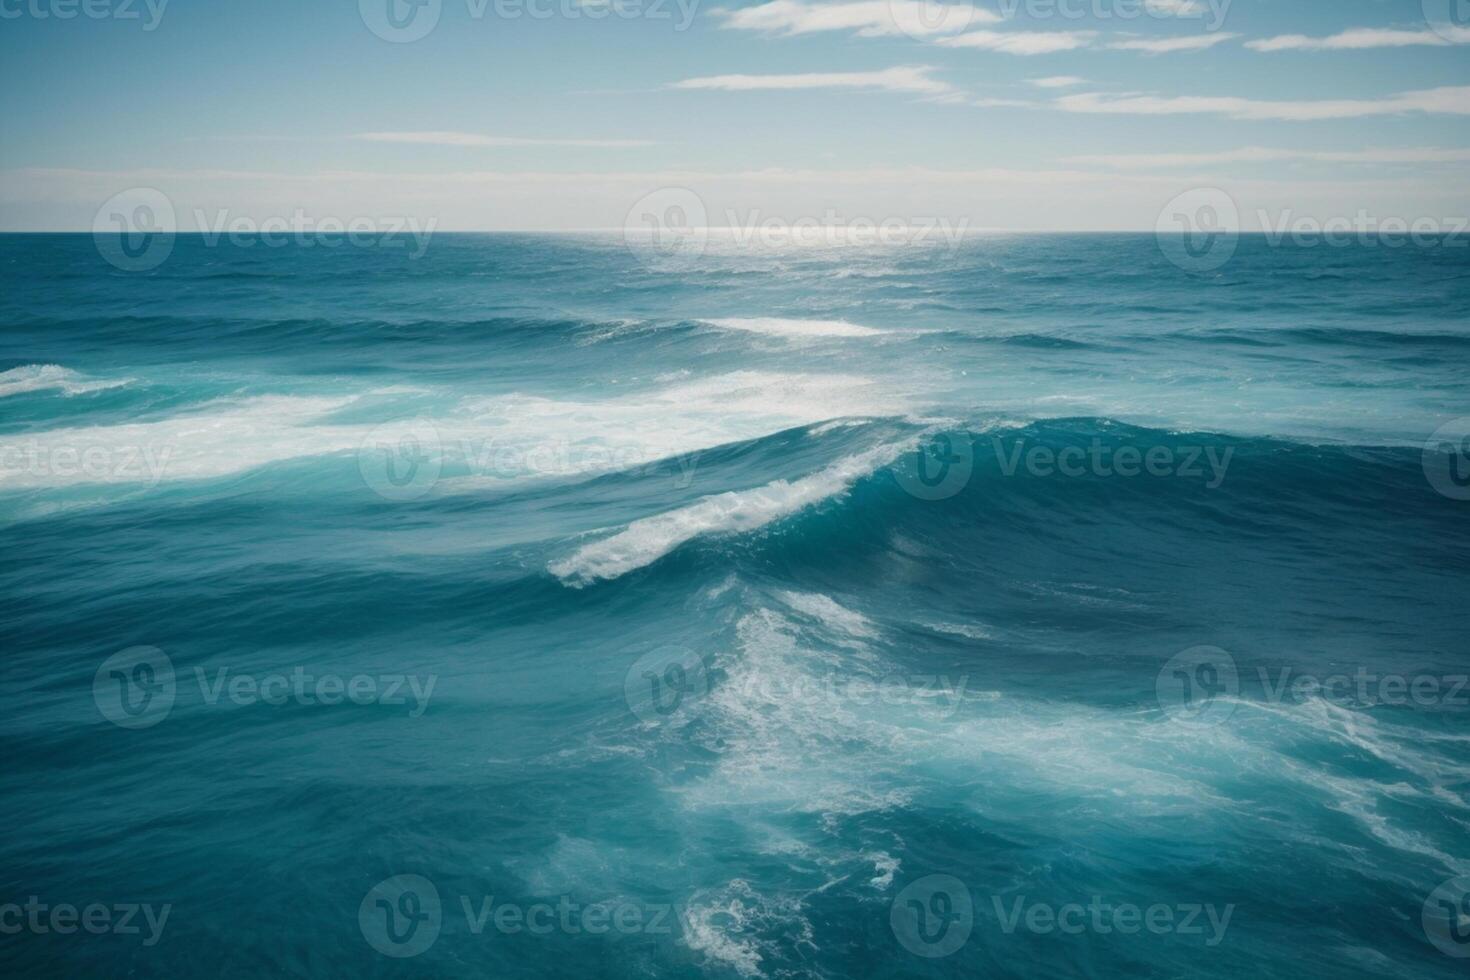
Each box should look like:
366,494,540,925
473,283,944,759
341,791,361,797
0,235,1470,979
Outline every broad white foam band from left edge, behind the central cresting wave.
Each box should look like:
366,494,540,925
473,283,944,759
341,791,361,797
0,373,901,489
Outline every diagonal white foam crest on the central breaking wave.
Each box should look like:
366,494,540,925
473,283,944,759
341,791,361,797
547,444,907,586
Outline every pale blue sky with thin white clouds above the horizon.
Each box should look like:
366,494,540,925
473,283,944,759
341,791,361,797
0,0,1470,231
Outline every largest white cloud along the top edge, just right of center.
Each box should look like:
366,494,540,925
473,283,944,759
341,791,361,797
713,0,1001,37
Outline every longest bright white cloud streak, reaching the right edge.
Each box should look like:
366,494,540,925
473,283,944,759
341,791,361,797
1053,85,1470,120
